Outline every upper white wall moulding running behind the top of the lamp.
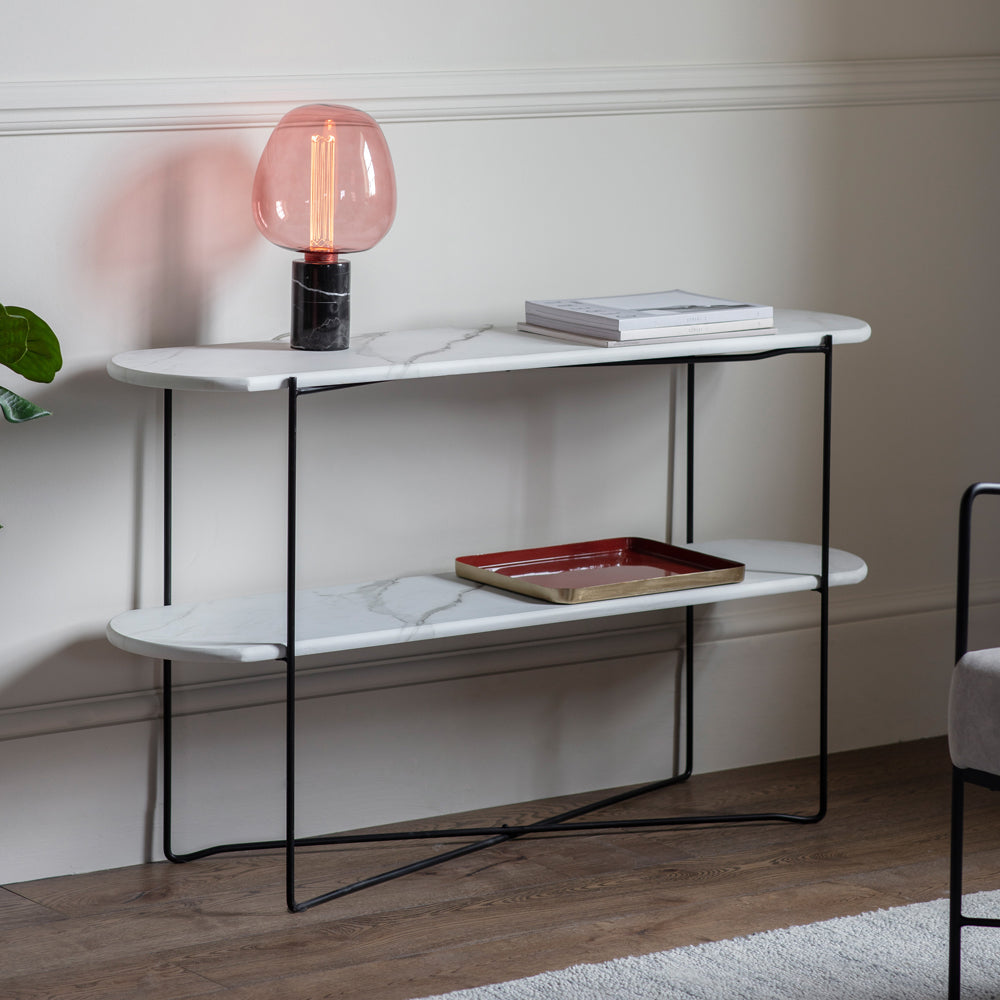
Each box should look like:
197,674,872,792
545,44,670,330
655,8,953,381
0,56,1000,136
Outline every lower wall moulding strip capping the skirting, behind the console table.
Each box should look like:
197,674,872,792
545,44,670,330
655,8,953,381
0,580,1000,742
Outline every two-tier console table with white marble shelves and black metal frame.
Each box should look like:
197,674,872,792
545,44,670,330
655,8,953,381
107,310,870,912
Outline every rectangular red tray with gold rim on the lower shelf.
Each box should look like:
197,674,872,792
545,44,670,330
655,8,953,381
455,537,746,604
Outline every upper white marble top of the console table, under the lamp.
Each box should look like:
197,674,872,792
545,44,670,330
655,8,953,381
108,309,871,392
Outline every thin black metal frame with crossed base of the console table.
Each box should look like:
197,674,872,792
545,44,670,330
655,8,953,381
163,336,833,913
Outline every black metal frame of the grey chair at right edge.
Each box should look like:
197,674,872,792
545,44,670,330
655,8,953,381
948,483,1000,1000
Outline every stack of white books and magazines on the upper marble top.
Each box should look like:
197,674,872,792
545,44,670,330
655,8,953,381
517,288,774,347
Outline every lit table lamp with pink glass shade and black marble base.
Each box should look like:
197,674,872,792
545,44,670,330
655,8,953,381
253,104,396,351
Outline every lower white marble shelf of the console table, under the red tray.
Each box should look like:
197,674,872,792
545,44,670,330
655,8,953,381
107,539,868,663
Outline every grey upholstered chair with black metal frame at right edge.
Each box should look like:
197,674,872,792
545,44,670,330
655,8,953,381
948,483,1000,1000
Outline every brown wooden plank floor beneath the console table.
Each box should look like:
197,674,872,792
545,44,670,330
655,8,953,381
0,739,1000,1000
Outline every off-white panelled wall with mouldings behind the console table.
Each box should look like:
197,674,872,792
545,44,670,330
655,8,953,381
0,0,1000,882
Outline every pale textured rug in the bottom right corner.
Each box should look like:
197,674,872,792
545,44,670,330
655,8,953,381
423,891,1000,1000
